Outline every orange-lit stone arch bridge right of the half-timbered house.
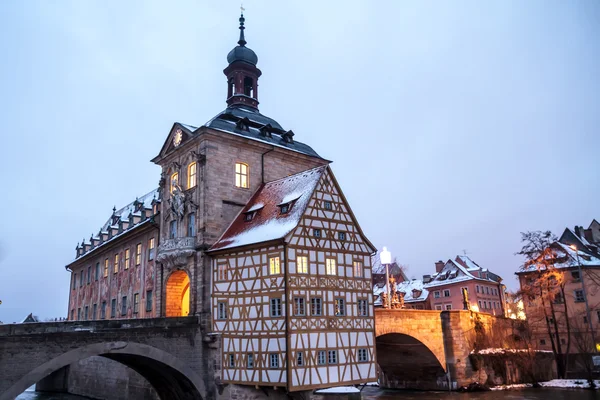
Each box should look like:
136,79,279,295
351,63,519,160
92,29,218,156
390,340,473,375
375,309,502,390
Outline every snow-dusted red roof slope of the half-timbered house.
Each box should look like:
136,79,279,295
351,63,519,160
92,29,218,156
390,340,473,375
211,166,327,250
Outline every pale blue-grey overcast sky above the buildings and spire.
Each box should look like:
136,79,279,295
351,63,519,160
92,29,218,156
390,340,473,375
0,0,600,323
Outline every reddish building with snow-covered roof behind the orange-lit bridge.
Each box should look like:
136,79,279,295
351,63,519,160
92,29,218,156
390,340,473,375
423,255,505,316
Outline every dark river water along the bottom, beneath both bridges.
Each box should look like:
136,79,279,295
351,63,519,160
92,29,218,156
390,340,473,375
17,387,600,400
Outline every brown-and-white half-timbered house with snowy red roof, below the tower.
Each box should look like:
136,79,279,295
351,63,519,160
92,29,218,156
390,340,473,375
209,167,376,391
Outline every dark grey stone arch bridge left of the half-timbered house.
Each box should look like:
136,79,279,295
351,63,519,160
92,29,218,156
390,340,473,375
0,317,211,400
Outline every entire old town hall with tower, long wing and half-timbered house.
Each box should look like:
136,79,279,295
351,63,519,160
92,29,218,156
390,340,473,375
66,15,376,392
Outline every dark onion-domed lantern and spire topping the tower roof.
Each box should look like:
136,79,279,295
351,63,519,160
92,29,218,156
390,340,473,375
223,13,262,110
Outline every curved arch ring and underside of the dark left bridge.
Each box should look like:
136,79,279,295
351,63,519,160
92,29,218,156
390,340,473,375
0,342,206,400
